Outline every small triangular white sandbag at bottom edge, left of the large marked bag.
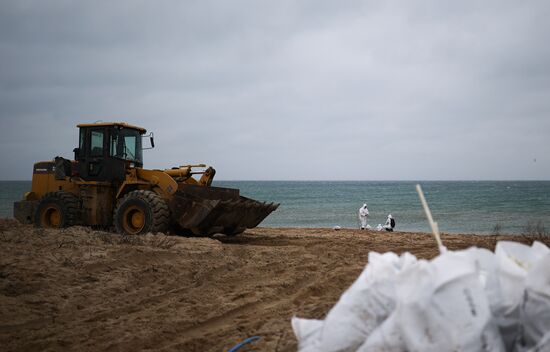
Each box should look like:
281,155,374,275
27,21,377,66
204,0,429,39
357,311,407,352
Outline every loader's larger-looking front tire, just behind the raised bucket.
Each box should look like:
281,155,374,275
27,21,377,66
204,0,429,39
114,190,170,235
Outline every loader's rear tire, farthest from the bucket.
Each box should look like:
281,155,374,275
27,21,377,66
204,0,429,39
34,191,79,229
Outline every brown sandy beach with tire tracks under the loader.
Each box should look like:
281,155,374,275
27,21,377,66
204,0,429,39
0,220,536,351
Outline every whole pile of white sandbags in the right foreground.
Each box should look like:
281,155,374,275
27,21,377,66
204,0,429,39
292,241,550,352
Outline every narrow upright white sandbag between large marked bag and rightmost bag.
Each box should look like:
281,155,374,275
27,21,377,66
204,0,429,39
486,241,550,351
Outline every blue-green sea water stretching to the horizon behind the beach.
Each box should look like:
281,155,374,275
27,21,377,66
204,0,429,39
0,181,550,234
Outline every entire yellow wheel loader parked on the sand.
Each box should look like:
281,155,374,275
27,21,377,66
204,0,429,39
14,122,279,236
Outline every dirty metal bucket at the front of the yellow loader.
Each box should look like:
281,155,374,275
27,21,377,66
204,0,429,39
169,184,279,236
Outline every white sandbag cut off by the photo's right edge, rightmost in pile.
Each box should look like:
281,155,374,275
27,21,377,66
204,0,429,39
516,253,550,351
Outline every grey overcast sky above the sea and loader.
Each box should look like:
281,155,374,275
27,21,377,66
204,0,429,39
0,0,550,180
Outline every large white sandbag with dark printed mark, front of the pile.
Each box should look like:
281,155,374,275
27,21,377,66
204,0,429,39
396,252,503,352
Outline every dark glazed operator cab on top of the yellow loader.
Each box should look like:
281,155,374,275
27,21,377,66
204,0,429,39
74,123,146,182
